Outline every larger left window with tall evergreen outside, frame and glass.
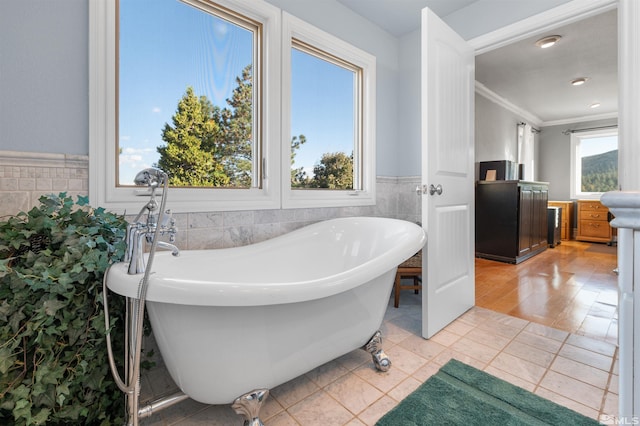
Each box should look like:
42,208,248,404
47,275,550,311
89,0,281,212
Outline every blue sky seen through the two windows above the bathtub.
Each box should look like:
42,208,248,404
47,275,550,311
119,0,354,184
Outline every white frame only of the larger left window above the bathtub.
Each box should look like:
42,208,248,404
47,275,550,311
89,0,281,212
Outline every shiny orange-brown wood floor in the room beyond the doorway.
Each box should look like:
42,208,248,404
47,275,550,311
476,241,618,344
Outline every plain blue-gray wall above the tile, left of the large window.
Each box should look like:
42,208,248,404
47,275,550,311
0,0,89,155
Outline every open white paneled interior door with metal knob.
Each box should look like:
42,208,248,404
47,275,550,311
421,9,475,338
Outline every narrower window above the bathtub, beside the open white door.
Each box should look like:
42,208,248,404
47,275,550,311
281,13,375,207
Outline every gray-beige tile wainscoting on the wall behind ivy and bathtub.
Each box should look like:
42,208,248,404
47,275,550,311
0,151,421,249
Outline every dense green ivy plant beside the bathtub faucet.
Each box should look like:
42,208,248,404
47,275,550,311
0,193,127,425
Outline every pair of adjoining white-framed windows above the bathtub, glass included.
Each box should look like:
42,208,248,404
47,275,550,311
89,0,375,212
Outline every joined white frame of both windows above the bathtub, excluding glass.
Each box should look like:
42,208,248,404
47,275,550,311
89,0,376,213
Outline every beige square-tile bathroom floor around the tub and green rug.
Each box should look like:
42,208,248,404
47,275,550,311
141,292,618,426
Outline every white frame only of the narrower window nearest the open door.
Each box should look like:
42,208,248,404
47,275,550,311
280,12,376,208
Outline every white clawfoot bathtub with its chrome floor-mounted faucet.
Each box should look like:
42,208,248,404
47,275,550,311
105,168,426,425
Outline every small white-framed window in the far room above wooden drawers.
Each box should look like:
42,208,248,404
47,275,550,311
571,128,618,198
